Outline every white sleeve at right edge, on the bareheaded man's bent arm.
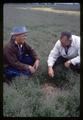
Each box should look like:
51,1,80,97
71,37,80,65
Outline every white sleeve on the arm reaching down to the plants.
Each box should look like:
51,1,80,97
47,40,60,67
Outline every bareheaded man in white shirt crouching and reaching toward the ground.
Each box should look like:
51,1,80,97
47,32,80,77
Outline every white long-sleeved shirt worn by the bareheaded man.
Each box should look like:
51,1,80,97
47,35,80,67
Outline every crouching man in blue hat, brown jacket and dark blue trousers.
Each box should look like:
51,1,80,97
4,26,40,83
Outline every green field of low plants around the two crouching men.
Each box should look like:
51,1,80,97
3,4,80,117
